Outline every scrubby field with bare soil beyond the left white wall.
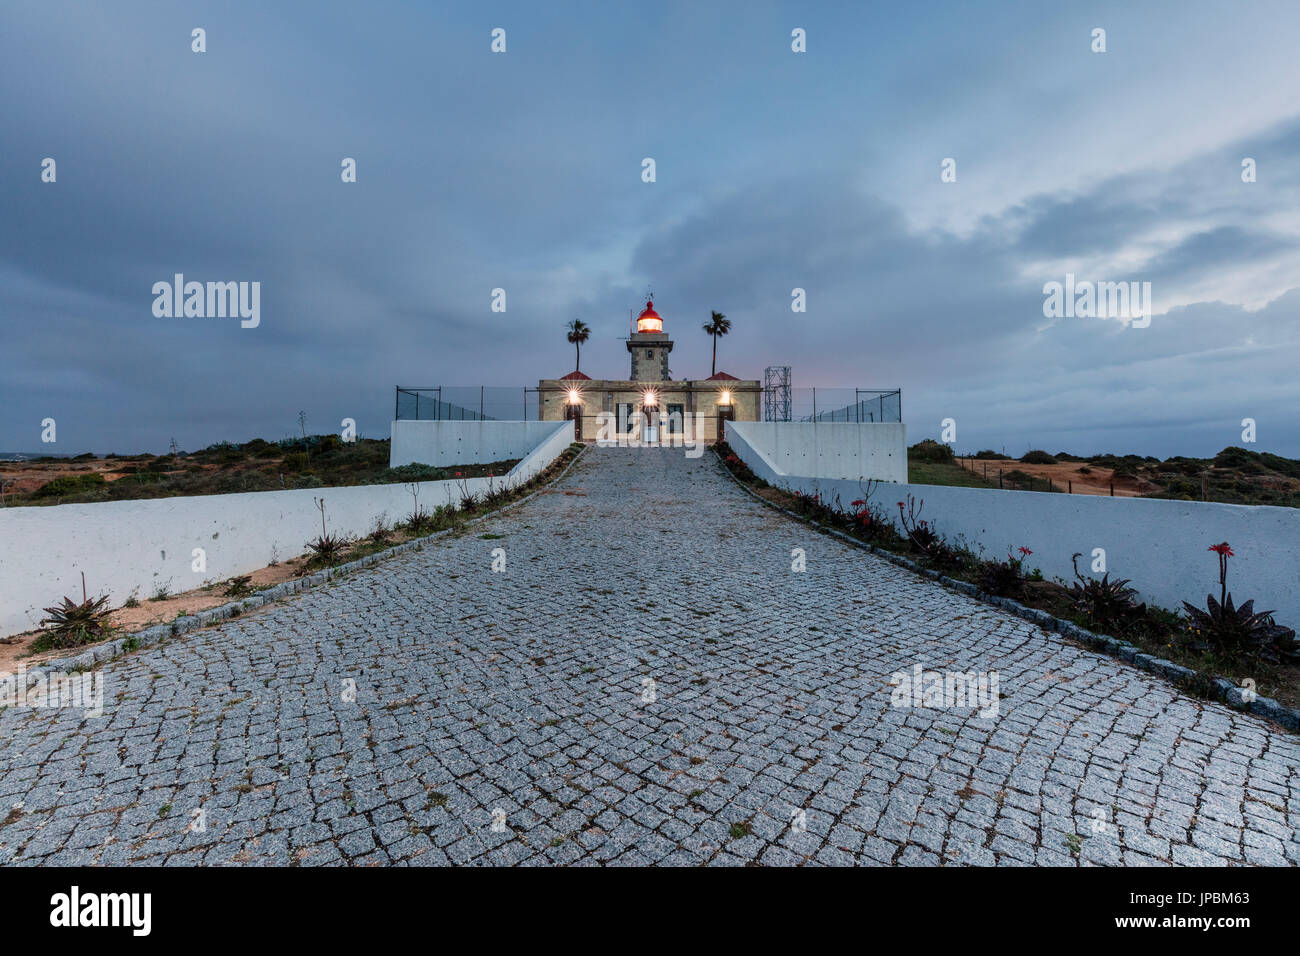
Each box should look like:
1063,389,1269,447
0,434,517,507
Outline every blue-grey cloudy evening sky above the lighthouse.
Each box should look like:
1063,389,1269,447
0,0,1300,457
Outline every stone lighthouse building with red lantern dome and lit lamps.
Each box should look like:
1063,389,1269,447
537,302,762,442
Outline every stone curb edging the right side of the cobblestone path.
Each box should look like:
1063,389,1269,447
714,451,1300,731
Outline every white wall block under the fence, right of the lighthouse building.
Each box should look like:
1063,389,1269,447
727,421,907,481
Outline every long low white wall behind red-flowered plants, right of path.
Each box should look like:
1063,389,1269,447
727,423,1300,628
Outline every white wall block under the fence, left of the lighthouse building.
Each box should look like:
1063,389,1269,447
389,421,559,468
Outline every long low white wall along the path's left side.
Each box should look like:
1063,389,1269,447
0,421,573,635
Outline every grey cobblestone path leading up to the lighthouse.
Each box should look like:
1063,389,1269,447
0,447,1300,865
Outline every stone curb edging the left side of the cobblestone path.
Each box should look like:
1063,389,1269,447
11,446,586,691
